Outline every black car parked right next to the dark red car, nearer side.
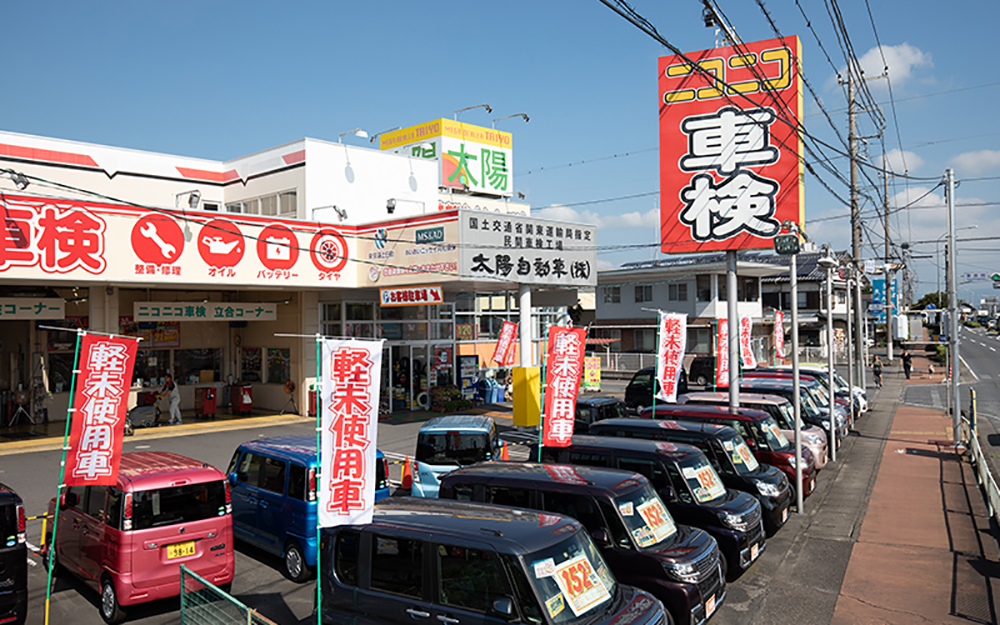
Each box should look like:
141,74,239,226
590,419,792,536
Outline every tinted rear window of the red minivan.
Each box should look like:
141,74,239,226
132,480,226,530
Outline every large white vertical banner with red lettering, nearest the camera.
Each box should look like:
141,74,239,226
318,339,384,527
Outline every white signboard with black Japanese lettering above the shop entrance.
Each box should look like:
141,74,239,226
458,211,597,286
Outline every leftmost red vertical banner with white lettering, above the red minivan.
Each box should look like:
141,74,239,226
63,334,139,486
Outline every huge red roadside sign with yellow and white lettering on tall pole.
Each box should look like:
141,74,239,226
658,36,805,253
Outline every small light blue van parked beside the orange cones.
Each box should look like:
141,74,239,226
412,415,504,497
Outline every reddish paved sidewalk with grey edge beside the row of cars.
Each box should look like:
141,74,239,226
712,358,1000,625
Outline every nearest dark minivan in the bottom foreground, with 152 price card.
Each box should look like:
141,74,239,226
314,497,667,625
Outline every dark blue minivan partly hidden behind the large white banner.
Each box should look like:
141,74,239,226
226,436,389,582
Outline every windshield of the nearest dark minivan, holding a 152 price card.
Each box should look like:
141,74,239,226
524,532,616,625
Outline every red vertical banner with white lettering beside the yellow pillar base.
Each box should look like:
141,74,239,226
542,326,587,447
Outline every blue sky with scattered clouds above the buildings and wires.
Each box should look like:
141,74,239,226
0,0,1000,300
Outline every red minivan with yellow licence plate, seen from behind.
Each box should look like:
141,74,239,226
43,452,235,623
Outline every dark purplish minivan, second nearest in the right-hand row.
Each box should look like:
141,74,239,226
441,462,726,625
